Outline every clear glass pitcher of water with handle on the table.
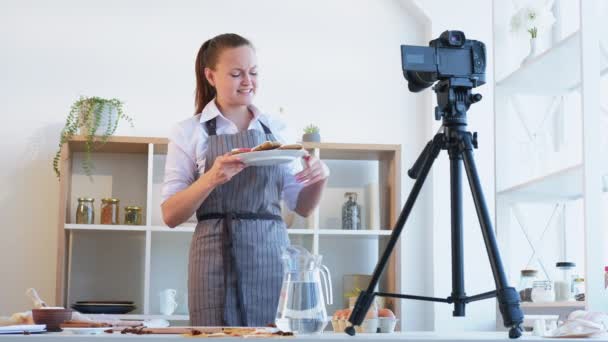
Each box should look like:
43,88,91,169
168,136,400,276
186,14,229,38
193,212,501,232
275,246,333,334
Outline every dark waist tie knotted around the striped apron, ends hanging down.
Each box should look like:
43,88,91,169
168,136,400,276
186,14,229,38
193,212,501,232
196,213,283,326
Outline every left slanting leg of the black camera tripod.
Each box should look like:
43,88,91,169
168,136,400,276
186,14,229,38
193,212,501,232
344,133,444,336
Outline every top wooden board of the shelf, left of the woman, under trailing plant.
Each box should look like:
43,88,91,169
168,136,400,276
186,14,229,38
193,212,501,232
68,136,168,153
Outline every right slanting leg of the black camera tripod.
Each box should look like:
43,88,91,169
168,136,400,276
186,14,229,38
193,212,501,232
460,132,524,338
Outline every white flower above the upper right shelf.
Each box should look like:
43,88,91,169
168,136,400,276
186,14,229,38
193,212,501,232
511,1,555,38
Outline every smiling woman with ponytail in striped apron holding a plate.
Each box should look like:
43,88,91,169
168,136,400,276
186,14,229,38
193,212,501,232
162,34,329,326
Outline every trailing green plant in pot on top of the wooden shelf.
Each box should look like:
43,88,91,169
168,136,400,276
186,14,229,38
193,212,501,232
53,96,133,178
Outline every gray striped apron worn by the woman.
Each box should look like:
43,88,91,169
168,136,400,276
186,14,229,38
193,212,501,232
188,119,289,326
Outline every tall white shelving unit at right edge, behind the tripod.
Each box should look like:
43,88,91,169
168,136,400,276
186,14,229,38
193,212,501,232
493,0,608,315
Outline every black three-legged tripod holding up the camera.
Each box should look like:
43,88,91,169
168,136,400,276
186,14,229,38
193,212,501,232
345,78,523,338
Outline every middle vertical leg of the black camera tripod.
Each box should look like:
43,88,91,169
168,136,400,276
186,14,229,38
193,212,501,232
449,149,466,317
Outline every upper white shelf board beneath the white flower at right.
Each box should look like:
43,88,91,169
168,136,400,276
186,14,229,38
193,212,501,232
496,31,608,95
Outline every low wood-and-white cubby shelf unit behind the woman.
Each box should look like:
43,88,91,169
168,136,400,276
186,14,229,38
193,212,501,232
56,137,401,324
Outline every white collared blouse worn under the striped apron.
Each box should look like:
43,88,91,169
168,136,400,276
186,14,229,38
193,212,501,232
161,100,303,210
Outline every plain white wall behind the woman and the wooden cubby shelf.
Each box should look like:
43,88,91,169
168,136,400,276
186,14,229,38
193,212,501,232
0,0,430,329
